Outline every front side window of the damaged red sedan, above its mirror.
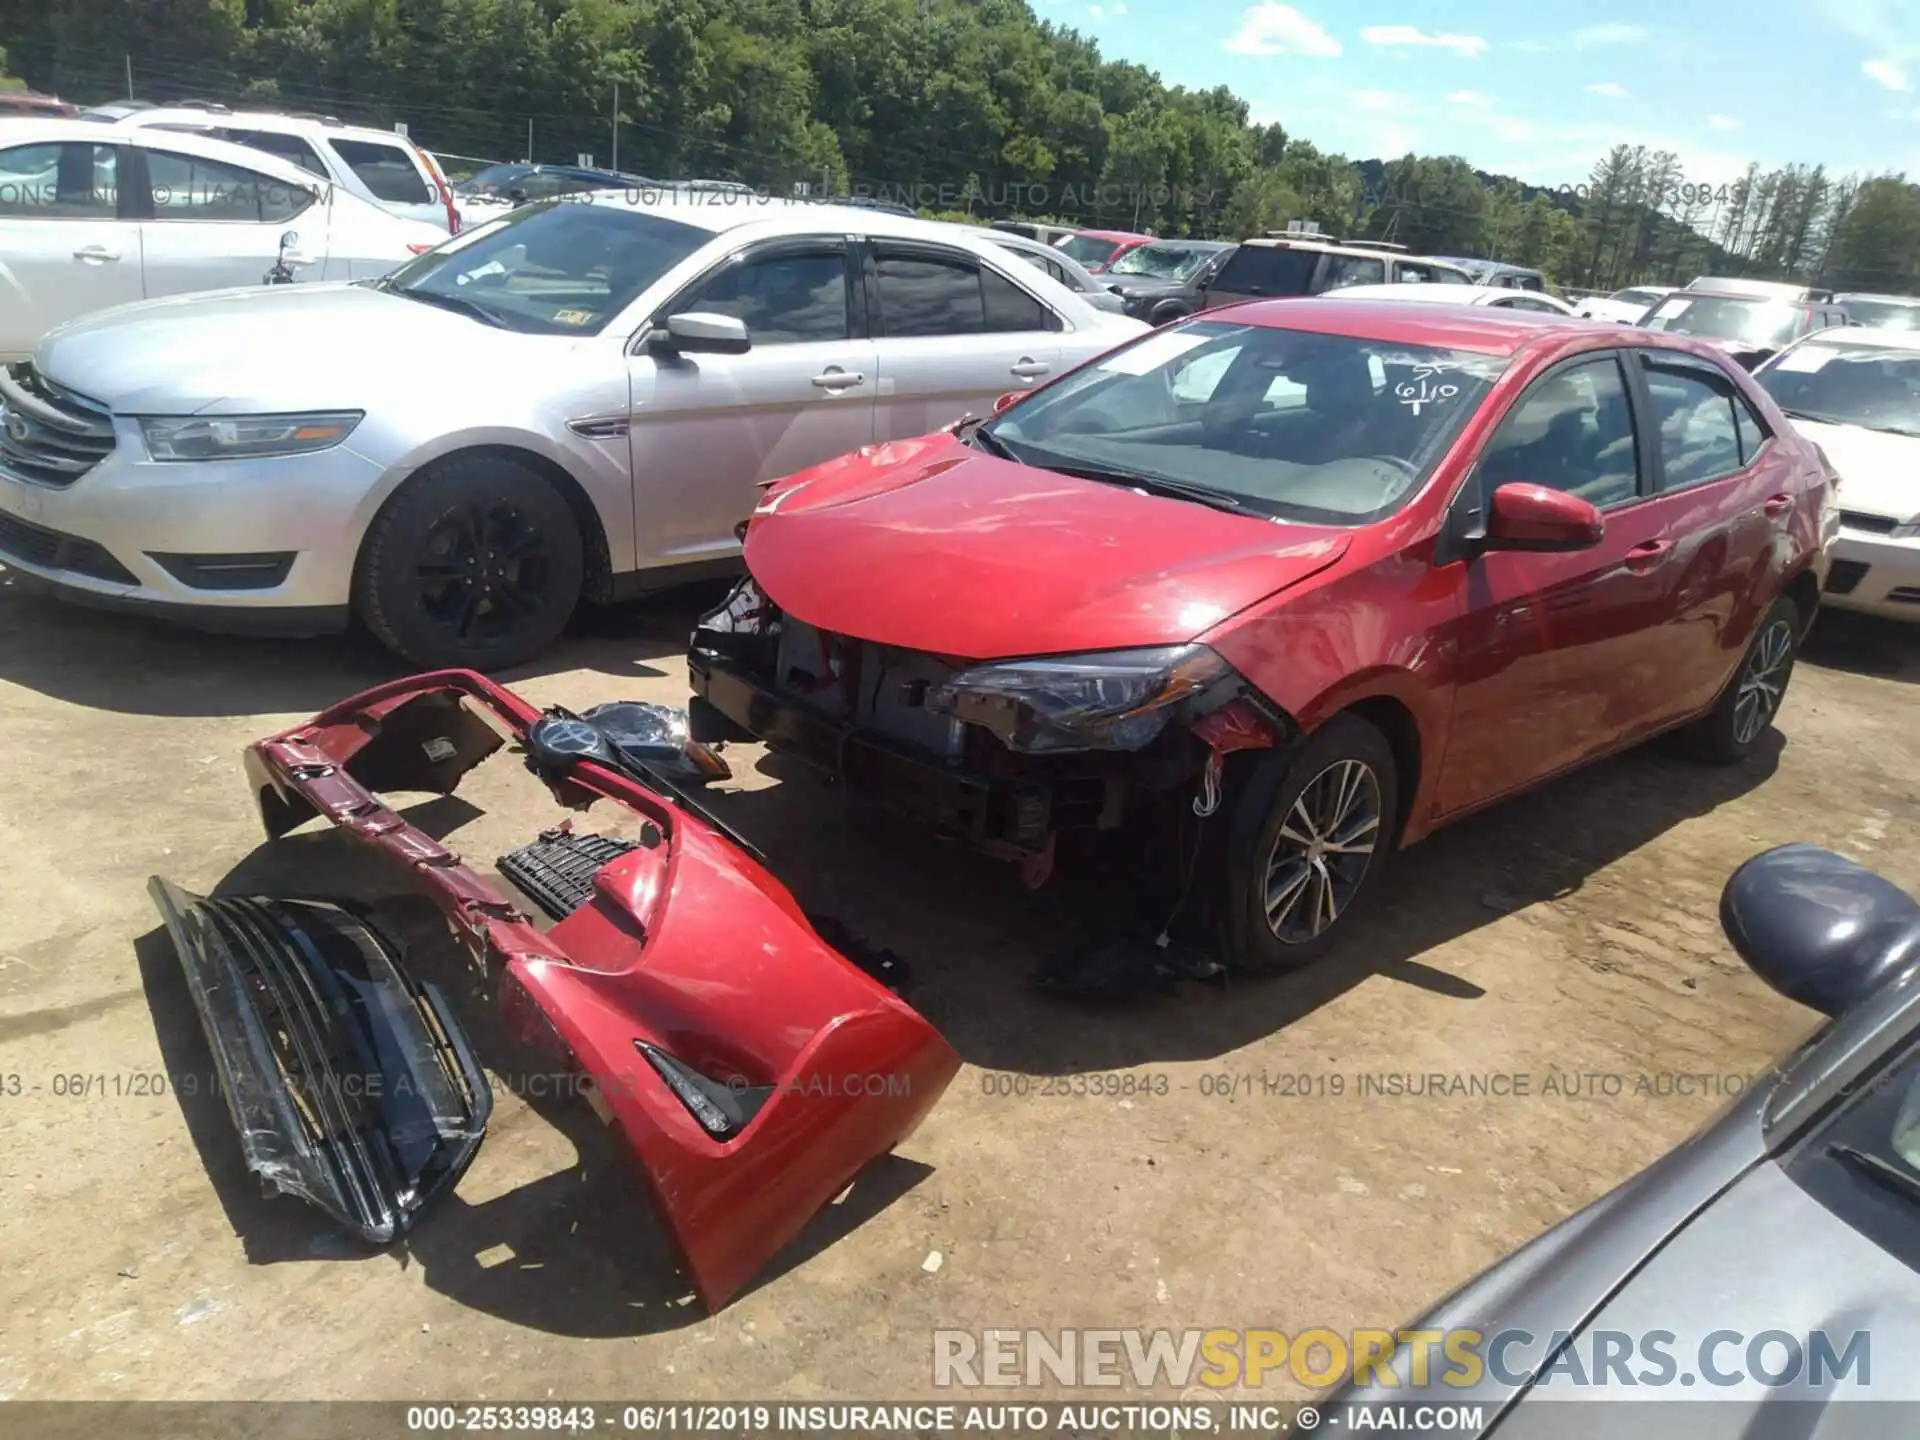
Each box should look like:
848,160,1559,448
1480,355,1640,509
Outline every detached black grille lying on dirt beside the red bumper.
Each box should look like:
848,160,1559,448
148,876,493,1244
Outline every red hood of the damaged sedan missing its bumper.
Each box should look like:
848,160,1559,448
747,434,1350,660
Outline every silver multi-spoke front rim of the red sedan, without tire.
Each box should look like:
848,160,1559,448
1265,760,1380,945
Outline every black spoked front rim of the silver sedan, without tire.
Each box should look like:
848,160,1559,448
415,501,553,641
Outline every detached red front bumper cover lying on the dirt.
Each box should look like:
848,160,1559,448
246,670,960,1308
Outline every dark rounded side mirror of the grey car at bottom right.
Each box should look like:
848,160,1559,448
1720,845,1920,1018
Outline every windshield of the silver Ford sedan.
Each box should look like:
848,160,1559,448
376,200,712,334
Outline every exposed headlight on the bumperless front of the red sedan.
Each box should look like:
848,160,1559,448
927,645,1231,753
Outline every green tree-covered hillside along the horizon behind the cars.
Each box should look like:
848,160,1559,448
0,0,1920,290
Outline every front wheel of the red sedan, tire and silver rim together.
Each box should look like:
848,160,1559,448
1221,714,1400,972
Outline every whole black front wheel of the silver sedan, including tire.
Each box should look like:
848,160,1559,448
353,455,586,670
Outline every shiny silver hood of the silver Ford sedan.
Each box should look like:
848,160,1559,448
35,284,487,415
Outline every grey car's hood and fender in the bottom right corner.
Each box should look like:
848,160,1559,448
1319,973,1920,1440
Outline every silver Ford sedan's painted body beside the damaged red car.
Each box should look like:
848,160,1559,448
0,192,1146,634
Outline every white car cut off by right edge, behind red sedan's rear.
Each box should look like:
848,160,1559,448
1753,326,1920,622
